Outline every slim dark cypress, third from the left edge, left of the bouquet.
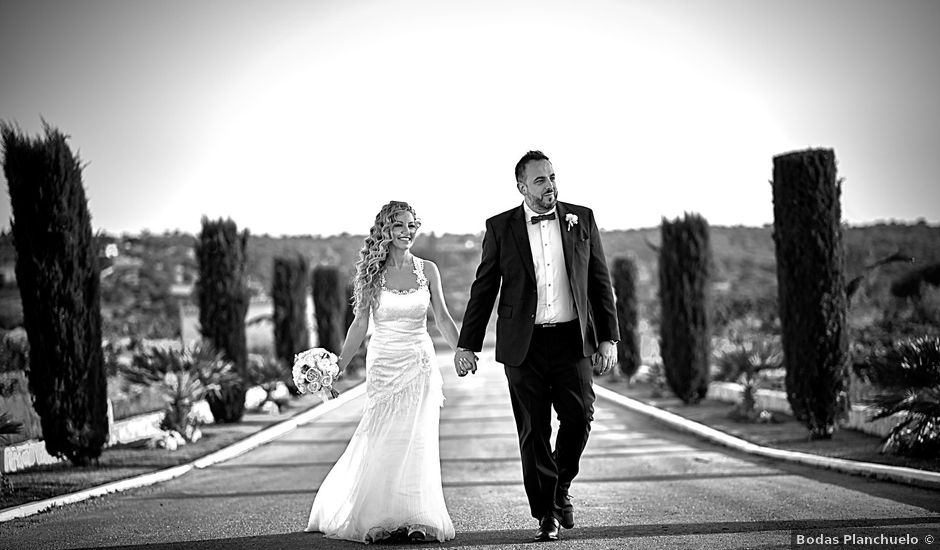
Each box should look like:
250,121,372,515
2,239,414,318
271,255,310,392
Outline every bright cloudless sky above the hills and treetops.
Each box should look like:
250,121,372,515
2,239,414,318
0,0,940,235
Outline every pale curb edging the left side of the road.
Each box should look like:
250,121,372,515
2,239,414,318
0,382,366,523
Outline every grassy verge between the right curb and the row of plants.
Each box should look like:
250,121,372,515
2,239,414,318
596,374,940,472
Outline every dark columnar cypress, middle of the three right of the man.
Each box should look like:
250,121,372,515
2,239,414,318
659,214,711,404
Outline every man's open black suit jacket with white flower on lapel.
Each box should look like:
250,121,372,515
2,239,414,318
457,202,620,366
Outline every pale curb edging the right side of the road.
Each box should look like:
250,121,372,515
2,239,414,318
594,384,940,490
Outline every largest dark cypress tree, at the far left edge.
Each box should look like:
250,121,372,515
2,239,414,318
0,122,108,465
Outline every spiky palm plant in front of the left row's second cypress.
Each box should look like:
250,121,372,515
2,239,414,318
121,344,238,440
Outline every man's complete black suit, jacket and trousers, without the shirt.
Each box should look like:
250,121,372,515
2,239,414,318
457,202,620,519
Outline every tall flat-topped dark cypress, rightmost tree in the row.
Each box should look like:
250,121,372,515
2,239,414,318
771,149,848,439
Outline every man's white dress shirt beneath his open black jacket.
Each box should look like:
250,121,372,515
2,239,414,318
522,202,578,325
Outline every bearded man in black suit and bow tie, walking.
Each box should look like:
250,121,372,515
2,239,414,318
454,151,620,541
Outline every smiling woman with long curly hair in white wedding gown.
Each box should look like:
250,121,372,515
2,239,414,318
306,201,457,543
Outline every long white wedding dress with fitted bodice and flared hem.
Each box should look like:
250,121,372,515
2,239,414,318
306,258,454,543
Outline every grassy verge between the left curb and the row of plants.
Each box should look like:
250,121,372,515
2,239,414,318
0,375,362,509
